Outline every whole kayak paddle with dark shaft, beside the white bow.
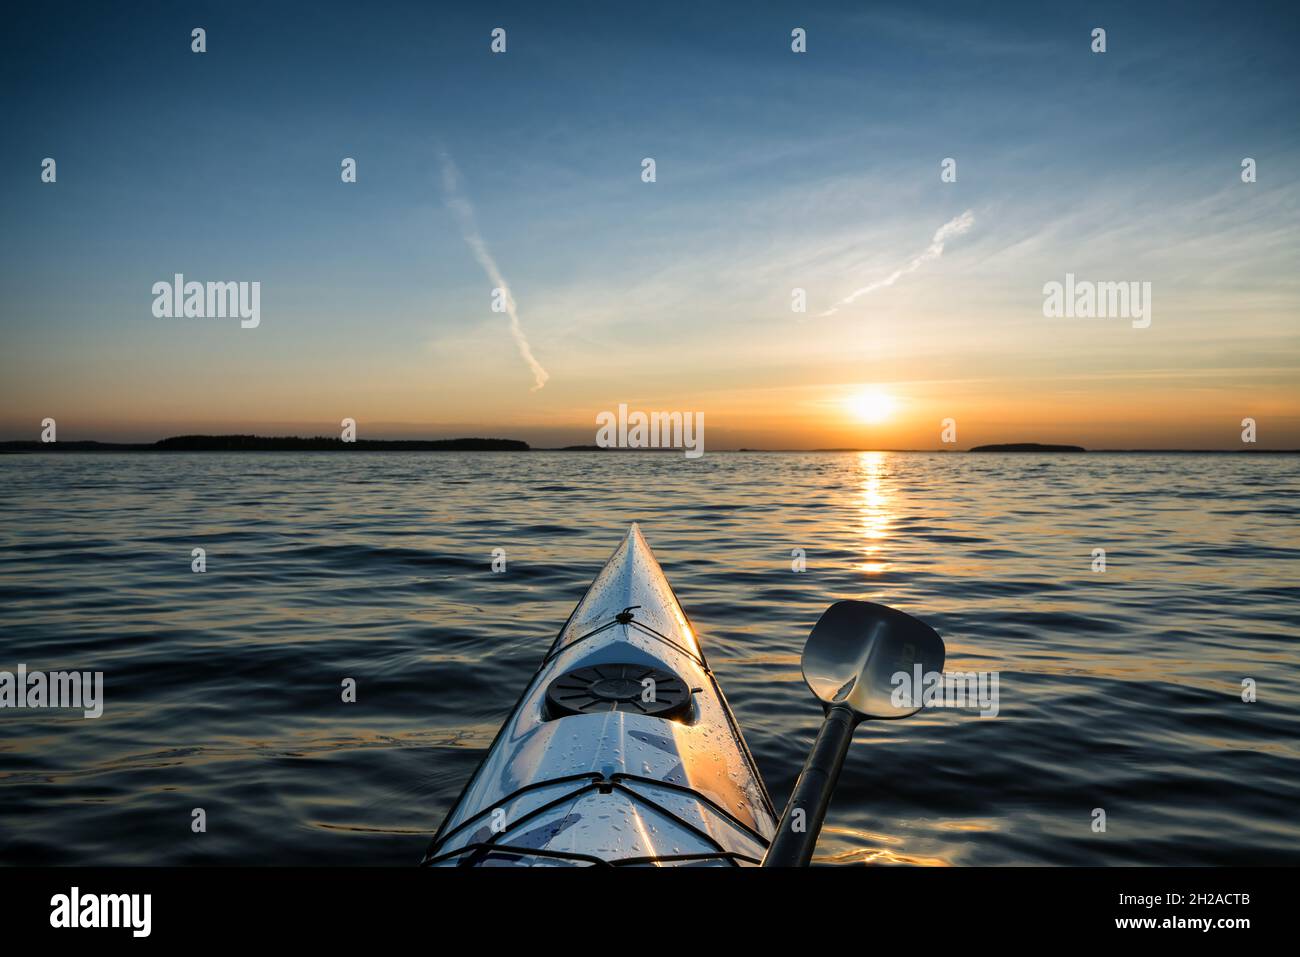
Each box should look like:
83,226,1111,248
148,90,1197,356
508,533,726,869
763,602,944,867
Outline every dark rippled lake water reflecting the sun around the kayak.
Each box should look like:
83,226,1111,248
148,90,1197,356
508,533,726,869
0,452,1300,865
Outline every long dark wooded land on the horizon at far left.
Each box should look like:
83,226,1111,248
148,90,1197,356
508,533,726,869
0,436,529,452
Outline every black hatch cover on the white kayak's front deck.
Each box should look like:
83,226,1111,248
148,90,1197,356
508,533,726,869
546,664,690,718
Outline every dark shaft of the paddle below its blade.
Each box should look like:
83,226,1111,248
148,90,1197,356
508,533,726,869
763,705,858,867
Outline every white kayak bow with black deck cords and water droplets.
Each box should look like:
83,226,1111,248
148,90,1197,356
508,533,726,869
421,524,777,867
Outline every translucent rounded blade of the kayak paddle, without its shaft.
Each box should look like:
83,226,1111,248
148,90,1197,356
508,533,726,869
803,601,944,719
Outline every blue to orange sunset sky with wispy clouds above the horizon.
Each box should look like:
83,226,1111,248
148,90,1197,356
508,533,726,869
0,3,1300,449
